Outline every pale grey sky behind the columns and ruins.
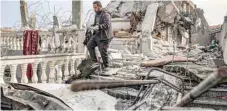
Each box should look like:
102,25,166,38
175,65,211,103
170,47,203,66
0,0,227,27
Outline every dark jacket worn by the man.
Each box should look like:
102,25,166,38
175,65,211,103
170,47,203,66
94,9,112,40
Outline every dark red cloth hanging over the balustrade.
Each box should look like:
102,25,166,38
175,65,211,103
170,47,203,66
23,30,39,79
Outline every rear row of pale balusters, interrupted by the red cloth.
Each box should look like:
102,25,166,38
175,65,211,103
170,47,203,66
1,30,85,56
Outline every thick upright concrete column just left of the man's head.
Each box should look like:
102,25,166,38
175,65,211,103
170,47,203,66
72,0,83,29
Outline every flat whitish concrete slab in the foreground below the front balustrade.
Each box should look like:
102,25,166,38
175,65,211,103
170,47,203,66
26,84,116,110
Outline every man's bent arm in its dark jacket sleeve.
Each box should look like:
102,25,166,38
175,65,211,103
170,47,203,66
99,13,111,30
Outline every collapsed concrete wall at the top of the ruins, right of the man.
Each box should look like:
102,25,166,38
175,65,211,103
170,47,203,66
106,0,211,49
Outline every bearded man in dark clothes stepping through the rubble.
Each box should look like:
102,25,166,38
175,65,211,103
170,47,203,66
87,1,112,70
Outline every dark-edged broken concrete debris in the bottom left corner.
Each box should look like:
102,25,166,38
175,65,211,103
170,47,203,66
1,84,72,110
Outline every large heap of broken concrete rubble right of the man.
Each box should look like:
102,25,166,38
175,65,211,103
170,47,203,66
73,1,227,110
